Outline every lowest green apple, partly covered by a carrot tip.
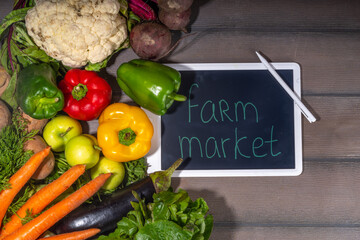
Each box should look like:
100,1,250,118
90,157,125,190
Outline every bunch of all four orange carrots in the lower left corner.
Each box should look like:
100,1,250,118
0,147,111,240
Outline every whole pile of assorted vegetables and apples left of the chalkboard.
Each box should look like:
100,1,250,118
0,0,213,240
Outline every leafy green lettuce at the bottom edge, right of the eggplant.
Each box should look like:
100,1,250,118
98,189,213,240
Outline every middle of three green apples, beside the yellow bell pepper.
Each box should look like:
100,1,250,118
65,134,101,169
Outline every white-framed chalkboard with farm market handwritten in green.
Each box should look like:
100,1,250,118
145,63,302,177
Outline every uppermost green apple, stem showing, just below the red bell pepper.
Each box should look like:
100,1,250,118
43,115,82,152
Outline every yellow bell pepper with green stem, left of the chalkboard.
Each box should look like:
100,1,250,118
97,103,154,162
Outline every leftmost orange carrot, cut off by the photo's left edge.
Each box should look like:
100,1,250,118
0,147,50,227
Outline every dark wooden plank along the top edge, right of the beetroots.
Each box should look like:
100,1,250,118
191,0,360,32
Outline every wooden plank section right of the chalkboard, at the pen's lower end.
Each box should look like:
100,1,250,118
303,96,360,159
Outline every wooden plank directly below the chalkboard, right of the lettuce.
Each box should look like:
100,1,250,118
172,161,360,227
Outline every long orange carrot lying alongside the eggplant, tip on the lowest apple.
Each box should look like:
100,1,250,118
4,173,111,240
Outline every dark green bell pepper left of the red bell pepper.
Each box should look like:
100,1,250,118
15,63,64,119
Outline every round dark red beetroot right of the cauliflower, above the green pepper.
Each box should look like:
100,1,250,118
130,22,171,60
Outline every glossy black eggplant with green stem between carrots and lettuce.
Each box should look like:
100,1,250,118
51,159,182,234
